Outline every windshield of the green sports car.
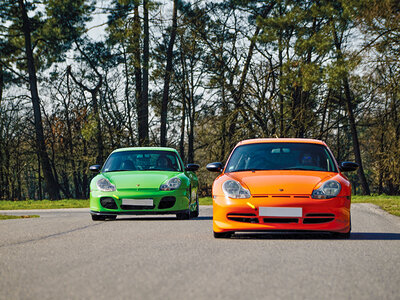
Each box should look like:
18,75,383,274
102,150,182,172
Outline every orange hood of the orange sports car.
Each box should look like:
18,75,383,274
225,171,337,195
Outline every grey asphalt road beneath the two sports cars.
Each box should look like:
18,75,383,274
0,204,400,299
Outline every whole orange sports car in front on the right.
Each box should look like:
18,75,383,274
207,138,358,238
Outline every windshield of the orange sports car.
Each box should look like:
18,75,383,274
225,143,337,172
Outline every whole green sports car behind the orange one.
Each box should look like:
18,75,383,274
90,147,199,221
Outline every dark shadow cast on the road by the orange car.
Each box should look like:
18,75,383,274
232,232,400,241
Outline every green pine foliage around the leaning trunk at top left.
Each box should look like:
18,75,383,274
0,0,94,69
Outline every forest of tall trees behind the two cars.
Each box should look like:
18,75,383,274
0,0,400,200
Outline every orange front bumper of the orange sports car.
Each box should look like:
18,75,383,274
213,195,350,233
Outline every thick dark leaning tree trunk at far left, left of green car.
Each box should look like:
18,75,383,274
18,0,60,200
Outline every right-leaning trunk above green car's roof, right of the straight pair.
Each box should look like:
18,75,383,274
160,0,178,147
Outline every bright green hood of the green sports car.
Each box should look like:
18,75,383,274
102,171,181,190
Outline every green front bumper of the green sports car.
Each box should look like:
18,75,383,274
90,189,190,215
